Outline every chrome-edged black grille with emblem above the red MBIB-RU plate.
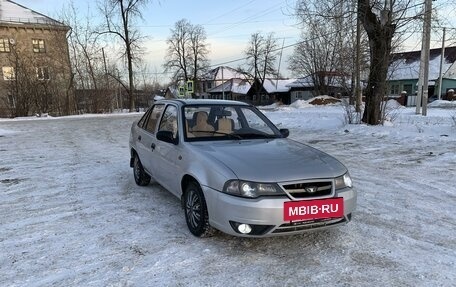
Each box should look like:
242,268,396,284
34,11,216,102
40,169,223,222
282,181,332,198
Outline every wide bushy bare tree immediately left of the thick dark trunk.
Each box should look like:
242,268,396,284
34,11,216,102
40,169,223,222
289,0,368,99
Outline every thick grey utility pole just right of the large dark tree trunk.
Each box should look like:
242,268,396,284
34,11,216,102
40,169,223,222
416,0,432,116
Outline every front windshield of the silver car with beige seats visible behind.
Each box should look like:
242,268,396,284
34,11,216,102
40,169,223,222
183,105,282,141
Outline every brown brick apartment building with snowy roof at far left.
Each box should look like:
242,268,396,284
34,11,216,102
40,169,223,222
0,0,74,117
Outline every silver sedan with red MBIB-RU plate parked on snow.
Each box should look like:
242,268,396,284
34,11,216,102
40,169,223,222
130,100,357,237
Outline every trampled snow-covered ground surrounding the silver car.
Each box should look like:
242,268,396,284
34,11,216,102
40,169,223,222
0,104,456,286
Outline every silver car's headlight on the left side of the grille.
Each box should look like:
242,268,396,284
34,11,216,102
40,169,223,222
223,179,284,198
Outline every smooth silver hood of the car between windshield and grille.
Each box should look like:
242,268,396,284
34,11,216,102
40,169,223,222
194,139,347,182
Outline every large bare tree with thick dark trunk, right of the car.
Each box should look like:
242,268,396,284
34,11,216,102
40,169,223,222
297,0,432,125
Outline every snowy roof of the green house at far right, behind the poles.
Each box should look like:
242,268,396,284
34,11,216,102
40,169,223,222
388,47,456,80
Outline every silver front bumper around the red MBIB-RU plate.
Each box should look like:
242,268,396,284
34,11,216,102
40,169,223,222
203,187,357,237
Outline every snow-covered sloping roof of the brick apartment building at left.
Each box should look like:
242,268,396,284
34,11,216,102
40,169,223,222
0,0,67,27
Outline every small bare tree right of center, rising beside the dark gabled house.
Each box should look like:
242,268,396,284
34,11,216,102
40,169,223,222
245,32,278,102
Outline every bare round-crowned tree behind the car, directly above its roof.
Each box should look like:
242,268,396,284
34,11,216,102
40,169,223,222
163,19,209,95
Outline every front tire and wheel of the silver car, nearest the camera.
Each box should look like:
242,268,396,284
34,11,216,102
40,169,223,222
184,182,214,237
